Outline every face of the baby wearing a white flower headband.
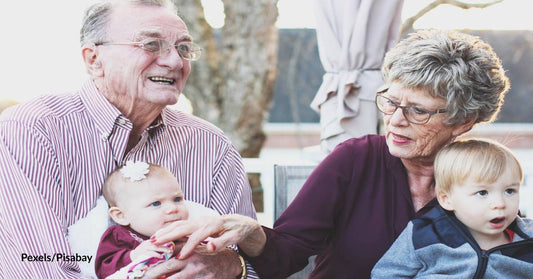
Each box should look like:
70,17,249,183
117,171,189,236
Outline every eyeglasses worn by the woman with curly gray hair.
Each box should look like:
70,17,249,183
376,94,448,125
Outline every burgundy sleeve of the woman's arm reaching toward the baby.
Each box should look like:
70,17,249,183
248,141,362,278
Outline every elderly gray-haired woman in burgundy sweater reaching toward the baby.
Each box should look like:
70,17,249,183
149,30,509,278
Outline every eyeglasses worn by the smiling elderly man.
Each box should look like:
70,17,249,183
95,38,202,61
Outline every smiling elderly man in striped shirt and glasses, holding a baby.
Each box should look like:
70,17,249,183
0,0,255,278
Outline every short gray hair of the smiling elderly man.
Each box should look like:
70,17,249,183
80,0,177,46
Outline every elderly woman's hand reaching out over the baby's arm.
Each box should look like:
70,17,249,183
151,214,266,260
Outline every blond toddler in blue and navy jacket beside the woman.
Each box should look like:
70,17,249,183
372,139,533,278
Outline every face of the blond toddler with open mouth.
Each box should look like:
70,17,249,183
443,164,520,246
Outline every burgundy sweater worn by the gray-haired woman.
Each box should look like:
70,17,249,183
245,135,437,279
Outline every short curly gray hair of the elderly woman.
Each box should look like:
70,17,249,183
382,30,510,125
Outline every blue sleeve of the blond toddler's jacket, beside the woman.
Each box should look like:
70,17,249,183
372,222,423,279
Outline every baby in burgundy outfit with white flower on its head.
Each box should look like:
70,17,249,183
95,161,189,278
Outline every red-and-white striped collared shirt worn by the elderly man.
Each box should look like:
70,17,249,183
0,81,256,278
